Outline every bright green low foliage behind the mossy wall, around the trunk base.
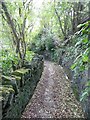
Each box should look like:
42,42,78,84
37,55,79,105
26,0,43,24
0,49,34,75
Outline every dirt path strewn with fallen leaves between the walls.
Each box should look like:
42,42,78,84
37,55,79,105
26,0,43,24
22,61,83,118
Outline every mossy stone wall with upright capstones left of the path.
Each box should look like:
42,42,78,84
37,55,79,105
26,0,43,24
2,55,44,118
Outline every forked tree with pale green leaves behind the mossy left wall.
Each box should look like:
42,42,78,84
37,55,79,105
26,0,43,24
0,1,31,66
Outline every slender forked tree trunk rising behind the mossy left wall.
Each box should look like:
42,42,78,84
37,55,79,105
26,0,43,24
0,2,26,67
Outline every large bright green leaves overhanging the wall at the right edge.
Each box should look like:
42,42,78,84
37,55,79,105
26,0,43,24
71,22,90,101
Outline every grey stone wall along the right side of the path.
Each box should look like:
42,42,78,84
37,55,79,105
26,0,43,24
61,60,90,118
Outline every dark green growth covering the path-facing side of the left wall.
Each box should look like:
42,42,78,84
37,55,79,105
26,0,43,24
5,57,43,118
